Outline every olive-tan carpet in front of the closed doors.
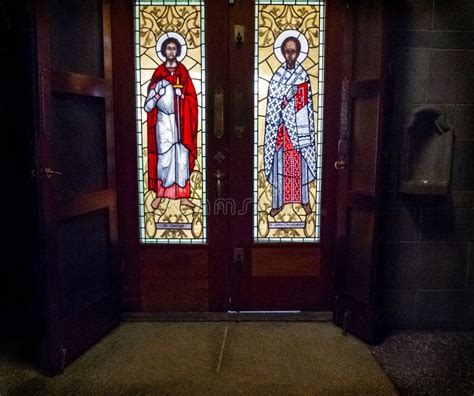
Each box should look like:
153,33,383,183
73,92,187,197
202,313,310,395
0,322,396,396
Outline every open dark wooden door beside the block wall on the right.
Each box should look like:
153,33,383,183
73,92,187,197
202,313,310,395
334,0,388,342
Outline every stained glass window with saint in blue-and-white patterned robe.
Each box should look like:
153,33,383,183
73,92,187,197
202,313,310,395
254,0,324,242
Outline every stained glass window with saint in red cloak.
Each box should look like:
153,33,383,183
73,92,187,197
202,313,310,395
135,0,206,243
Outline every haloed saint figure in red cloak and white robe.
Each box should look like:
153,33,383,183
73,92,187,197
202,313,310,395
144,35,198,209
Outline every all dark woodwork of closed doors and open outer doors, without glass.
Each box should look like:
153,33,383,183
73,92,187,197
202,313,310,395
36,0,387,373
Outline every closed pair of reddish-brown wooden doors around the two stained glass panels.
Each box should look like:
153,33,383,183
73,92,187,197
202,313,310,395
112,0,356,312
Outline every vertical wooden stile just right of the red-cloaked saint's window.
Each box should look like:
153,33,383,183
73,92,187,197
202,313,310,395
205,1,233,311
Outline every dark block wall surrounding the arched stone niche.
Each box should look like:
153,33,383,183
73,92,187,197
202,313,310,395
385,0,474,328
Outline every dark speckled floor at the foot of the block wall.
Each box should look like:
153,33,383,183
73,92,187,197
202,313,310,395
370,330,474,396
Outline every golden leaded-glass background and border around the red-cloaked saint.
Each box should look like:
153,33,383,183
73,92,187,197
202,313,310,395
134,0,207,244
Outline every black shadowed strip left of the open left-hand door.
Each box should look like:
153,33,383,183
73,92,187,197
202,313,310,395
0,0,40,372
